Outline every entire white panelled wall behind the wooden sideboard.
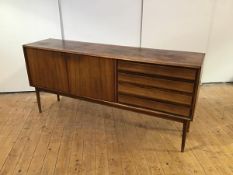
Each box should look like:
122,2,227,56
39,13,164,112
0,0,233,92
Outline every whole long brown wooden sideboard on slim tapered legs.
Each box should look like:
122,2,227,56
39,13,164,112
23,39,204,152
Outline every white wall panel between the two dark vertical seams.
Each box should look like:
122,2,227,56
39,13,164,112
61,0,141,46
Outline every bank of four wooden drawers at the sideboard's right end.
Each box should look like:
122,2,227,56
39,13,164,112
117,61,198,118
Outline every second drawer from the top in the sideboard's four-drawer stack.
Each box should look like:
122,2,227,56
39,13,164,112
118,72,194,93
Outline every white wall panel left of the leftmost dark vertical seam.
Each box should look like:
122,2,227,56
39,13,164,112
0,0,60,92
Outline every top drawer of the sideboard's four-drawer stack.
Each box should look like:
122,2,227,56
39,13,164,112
118,61,196,80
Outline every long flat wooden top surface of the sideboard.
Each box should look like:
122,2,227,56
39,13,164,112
24,39,205,68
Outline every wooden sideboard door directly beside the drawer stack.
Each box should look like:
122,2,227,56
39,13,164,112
67,54,116,101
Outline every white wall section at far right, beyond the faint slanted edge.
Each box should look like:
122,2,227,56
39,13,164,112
202,0,233,82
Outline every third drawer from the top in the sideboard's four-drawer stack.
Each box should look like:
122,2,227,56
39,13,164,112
118,82,192,105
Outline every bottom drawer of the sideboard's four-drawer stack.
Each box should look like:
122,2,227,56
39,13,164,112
118,94,190,117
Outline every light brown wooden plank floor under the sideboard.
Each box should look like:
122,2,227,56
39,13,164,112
0,84,233,175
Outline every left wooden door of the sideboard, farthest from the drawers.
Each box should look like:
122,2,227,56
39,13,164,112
25,48,69,93
